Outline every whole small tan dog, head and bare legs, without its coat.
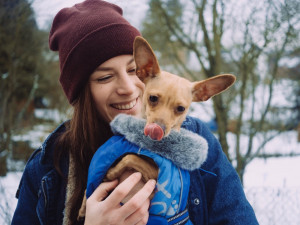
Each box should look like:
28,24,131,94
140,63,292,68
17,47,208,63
79,37,235,220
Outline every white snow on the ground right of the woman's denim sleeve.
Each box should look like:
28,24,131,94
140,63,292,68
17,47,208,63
244,131,300,225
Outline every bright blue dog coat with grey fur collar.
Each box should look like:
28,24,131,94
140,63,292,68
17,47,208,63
86,114,208,225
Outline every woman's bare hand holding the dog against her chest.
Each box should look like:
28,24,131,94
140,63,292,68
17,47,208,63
85,172,156,225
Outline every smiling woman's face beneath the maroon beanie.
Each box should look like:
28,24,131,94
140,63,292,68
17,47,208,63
89,55,145,122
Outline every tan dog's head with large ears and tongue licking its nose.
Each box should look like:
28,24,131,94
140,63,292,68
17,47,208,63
134,37,235,140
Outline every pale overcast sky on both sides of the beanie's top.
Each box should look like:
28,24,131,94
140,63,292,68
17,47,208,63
32,0,148,28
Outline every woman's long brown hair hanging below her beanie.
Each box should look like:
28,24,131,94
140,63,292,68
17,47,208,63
54,83,112,224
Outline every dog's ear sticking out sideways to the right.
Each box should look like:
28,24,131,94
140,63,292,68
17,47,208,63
192,74,236,102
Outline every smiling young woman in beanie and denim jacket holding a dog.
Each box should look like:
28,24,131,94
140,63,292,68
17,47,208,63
12,0,257,225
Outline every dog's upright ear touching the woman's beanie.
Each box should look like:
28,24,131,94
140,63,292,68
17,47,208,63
133,37,160,82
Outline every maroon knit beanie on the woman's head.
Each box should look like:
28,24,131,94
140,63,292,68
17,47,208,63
49,0,141,104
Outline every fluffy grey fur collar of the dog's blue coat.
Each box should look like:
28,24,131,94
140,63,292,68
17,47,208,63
110,114,208,171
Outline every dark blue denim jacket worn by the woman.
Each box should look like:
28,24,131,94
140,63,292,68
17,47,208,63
12,117,258,225
